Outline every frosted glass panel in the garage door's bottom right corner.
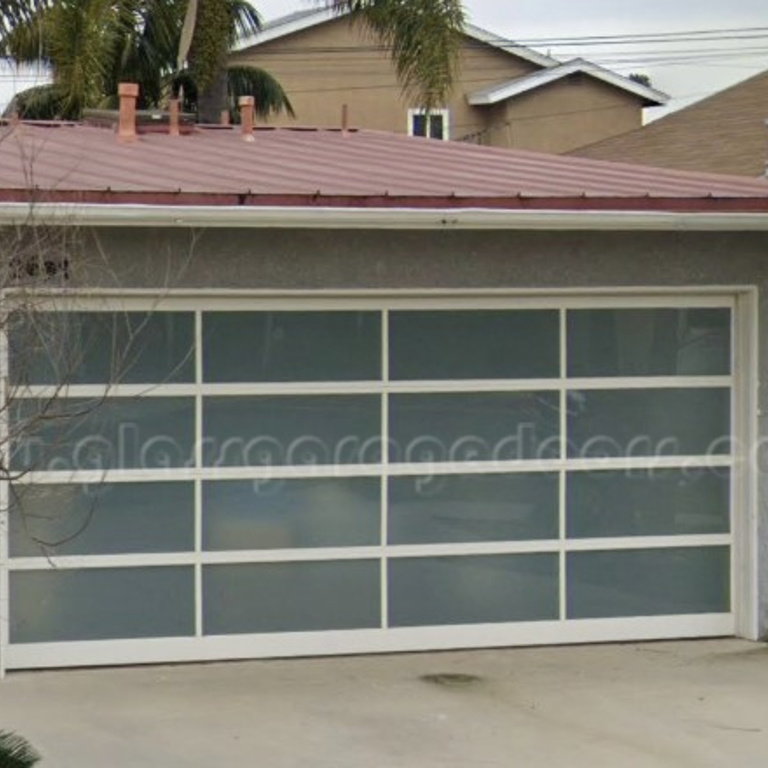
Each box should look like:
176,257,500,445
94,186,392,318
567,547,731,619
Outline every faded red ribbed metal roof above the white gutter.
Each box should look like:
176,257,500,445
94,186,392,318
0,123,768,211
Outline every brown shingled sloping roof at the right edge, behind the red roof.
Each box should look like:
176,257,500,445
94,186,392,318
573,70,768,177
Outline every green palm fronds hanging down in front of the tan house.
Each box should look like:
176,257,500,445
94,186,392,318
325,0,464,109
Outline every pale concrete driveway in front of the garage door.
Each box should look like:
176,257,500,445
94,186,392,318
0,640,768,768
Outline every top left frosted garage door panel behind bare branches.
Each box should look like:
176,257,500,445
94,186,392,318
9,312,195,384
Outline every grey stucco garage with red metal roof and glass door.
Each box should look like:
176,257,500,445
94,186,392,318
0,89,768,669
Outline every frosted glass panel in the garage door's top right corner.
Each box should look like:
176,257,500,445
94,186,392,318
568,309,731,377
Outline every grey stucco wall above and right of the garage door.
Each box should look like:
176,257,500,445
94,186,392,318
78,229,768,634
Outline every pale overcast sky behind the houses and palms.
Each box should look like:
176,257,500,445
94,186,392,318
0,0,768,118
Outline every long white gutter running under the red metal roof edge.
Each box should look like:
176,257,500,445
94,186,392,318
0,203,768,232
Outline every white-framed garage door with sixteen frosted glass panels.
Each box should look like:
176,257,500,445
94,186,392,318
0,298,734,668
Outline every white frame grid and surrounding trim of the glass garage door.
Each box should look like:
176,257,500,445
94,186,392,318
0,287,758,674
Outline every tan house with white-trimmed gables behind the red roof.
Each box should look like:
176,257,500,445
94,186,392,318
230,9,667,153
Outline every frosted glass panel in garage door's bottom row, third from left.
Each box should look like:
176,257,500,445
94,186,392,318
389,554,559,627
